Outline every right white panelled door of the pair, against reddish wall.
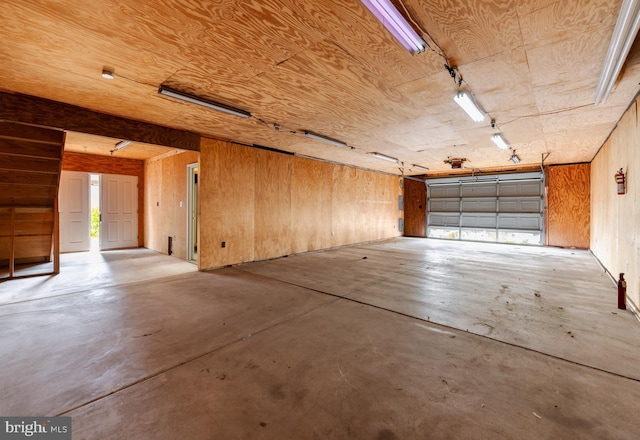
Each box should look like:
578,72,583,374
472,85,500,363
100,174,138,250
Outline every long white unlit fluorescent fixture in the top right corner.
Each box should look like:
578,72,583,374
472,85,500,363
595,0,640,104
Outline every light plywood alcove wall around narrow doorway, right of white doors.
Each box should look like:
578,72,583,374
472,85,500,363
144,151,199,260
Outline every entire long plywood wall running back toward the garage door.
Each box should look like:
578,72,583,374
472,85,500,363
199,139,402,269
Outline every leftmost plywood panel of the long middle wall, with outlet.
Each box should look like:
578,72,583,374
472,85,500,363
199,139,258,269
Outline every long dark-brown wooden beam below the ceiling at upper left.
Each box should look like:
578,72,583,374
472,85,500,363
0,92,200,151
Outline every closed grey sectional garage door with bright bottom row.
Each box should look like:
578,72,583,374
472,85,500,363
426,173,544,245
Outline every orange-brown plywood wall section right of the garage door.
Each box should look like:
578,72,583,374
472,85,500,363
546,163,591,249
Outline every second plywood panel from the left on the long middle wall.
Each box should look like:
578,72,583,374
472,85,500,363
254,150,293,260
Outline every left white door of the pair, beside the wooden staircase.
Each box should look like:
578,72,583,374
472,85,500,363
59,171,91,252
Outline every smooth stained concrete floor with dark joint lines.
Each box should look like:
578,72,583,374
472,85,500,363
0,238,640,440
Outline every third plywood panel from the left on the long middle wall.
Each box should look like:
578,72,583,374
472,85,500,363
291,156,335,253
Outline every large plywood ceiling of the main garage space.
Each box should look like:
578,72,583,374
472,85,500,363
0,0,640,174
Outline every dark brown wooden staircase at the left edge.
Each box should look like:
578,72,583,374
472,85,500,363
0,122,64,279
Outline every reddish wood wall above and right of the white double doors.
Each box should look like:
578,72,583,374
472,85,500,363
62,151,144,246
